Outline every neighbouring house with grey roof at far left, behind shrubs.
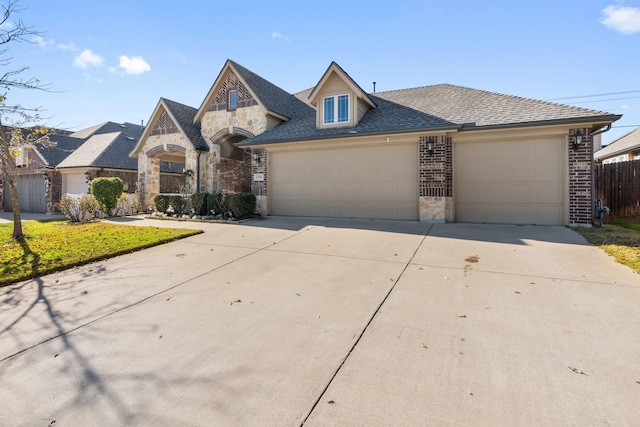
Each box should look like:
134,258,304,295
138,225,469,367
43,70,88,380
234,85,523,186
4,122,183,213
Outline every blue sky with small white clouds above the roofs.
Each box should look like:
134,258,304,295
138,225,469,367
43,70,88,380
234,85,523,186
0,0,640,143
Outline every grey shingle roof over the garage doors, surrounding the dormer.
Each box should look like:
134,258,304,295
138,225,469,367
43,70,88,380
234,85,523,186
238,84,618,146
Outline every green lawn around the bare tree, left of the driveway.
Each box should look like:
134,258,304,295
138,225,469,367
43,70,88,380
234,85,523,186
0,221,202,286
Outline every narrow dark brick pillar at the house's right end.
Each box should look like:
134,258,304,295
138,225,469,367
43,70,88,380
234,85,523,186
567,128,593,226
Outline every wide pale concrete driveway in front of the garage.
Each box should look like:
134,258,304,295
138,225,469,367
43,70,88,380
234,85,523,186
0,217,640,426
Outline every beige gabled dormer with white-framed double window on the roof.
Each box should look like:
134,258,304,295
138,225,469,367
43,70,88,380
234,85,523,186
309,61,376,129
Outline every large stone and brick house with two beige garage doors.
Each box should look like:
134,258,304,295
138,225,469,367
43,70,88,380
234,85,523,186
131,60,621,225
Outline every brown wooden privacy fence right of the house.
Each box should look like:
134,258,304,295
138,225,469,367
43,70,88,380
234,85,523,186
594,160,640,217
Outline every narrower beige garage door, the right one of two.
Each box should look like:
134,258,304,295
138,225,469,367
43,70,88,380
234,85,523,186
454,138,566,225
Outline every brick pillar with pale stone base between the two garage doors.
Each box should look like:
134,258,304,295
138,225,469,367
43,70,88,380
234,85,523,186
418,135,453,222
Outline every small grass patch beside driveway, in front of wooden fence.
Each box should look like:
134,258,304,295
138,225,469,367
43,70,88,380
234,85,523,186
575,217,640,273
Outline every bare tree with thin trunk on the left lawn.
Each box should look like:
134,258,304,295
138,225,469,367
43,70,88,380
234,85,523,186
0,0,49,240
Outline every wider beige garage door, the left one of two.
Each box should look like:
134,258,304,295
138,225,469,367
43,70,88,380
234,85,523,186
268,144,418,220
